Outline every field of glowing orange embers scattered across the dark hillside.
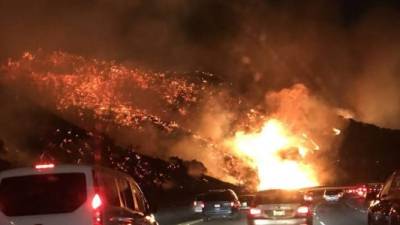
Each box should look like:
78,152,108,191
1,51,201,131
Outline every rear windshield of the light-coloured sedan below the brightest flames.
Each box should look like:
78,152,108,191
254,190,304,205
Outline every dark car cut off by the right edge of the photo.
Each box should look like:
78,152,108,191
368,170,400,225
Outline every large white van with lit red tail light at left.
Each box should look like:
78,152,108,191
0,164,158,225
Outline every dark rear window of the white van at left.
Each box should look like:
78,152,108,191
0,173,86,216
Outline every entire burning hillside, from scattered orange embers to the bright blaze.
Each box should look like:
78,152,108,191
1,51,342,192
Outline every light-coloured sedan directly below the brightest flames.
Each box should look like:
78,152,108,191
247,189,313,225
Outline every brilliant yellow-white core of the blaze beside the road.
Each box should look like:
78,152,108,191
229,119,318,190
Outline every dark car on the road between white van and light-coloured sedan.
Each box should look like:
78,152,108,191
203,189,240,221
